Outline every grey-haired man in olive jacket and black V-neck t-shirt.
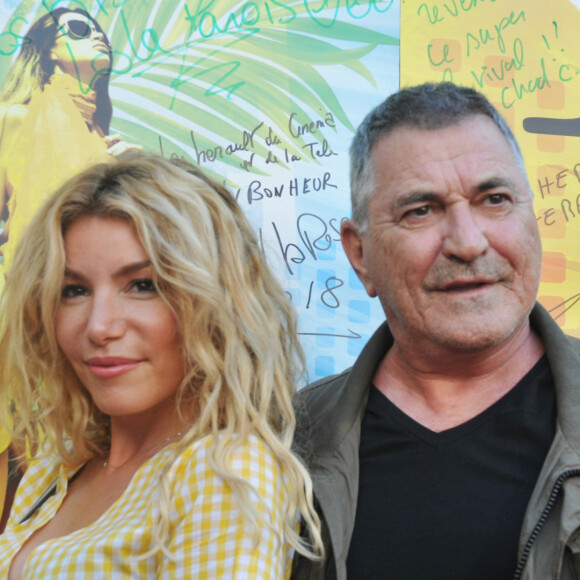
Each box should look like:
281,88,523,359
294,83,580,580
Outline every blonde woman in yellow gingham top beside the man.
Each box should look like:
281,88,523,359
0,154,321,580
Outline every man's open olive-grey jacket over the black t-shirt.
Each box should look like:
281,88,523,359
292,305,580,580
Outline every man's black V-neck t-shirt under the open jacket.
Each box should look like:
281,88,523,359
347,356,556,580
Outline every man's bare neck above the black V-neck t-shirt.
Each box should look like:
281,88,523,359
373,328,544,432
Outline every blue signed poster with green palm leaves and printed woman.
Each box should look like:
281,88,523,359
0,0,400,380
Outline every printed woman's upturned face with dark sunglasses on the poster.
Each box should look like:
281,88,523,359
50,12,111,85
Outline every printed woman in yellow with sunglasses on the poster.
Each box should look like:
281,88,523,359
0,8,134,278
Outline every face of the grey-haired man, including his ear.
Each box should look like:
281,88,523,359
343,115,541,352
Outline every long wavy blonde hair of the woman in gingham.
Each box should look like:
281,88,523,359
0,153,322,557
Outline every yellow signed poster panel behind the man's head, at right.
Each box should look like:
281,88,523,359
401,0,580,337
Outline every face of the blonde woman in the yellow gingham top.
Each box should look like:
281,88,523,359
56,216,185,421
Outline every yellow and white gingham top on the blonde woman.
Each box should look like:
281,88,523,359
0,435,293,580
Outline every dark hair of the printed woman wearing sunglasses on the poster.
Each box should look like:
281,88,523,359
0,7,113,134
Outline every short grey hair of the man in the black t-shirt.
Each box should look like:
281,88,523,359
350,83,527,232
